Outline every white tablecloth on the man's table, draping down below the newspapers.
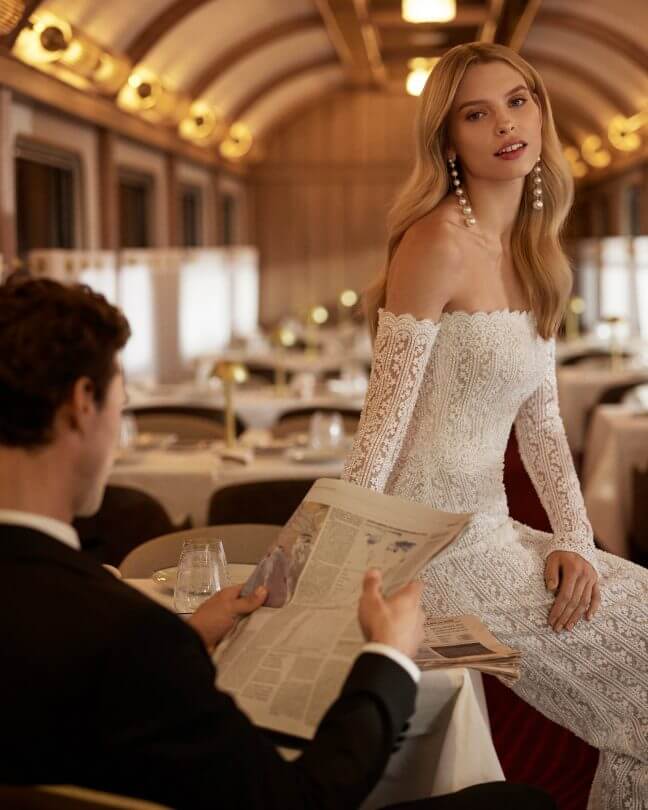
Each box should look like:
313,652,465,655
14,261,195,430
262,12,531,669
126,576,504,810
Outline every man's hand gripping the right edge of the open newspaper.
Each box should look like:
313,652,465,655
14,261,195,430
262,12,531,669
358,569,424,658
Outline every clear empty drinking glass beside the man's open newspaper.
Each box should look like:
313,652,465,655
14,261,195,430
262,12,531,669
173,540,230,613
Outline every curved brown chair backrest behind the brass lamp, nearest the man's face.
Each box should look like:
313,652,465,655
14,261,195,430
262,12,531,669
128,405,245,440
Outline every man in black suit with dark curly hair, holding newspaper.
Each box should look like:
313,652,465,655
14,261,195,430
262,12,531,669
0,280,552,810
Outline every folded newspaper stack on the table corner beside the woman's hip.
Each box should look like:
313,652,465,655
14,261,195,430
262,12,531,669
415,616,521,685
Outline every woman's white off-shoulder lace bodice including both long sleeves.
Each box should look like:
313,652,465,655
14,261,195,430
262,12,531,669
344,310,594,564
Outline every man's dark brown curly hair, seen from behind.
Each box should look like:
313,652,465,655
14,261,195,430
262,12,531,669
0,277,130,448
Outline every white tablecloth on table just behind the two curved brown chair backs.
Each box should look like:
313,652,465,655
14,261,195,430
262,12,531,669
128,384,364,428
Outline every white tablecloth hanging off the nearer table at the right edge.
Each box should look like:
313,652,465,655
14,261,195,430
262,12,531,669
583,405,648,557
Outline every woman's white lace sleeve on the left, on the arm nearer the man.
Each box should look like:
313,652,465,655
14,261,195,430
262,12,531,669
342,310,439,492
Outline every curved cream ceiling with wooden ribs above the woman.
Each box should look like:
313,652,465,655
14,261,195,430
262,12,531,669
8,0,648,170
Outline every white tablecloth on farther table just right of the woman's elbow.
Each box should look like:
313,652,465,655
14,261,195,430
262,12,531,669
557,364,648,453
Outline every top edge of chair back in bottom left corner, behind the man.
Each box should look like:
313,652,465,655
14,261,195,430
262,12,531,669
0,785,170,810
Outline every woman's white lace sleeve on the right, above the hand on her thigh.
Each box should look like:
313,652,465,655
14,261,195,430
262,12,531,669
515,341,597,569
